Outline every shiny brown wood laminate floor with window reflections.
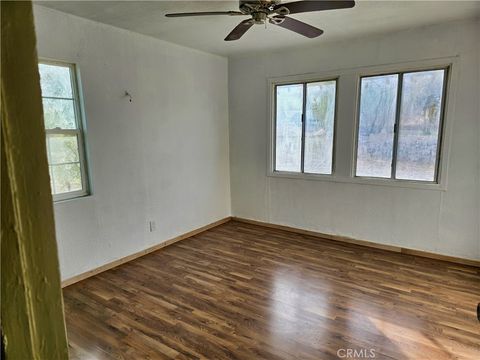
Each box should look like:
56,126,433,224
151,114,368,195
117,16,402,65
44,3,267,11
64,221,480,360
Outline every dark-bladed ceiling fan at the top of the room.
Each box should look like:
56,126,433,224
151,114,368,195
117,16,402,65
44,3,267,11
165,0,355,41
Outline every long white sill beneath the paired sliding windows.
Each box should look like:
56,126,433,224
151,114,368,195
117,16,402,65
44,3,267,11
267,171,447,191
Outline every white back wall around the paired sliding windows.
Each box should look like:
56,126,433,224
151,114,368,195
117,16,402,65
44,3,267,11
229,21,480,259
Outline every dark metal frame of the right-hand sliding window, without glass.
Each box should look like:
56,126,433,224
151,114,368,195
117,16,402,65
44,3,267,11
352,64,452,185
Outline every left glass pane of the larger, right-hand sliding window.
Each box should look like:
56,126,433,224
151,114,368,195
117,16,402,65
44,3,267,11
356,74,398,178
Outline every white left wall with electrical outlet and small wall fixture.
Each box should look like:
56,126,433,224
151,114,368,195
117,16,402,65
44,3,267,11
35,6,230,279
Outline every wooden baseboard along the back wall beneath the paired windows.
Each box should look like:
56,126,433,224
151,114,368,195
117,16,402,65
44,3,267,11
231,216,480,267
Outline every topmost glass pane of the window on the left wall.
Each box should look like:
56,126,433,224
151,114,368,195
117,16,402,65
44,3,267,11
38,64,73,98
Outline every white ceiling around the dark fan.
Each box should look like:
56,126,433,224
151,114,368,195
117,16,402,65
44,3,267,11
37,0,480,56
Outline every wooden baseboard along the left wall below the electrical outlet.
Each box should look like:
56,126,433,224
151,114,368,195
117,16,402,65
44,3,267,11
62,216,231,288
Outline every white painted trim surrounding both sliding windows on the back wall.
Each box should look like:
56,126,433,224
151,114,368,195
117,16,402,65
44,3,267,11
266,55,460,191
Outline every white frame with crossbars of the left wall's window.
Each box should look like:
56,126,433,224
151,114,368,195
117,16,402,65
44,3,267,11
38,58,91,202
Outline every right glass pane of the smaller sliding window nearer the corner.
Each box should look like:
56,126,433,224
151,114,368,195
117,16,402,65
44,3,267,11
304,81,336,174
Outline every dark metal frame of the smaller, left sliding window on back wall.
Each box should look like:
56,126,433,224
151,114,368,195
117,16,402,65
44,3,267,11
270,76,339,177
